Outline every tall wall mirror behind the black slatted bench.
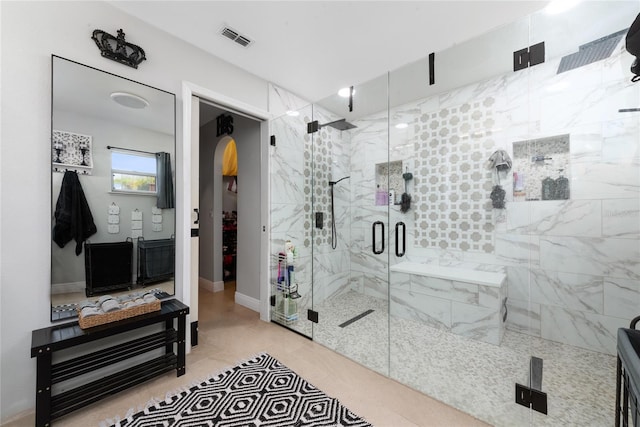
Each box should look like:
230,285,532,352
51,55,176,320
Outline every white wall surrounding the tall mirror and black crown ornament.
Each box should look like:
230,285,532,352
0,2,268,422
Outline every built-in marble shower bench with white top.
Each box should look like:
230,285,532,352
390,261,507,345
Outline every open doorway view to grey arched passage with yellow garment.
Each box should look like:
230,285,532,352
198,98,261,311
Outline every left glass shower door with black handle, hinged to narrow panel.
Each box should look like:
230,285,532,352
311,75,393,375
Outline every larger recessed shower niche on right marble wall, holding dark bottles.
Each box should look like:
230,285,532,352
511,134,571,202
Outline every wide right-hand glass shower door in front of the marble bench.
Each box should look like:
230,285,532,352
389,13,532,425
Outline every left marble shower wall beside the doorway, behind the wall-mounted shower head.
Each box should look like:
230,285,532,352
269,86,351,335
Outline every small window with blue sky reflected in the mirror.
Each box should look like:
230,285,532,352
111,151,156,195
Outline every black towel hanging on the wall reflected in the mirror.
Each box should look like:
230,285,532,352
53,171,98,255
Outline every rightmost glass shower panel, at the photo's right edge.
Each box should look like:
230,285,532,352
510,1,640,425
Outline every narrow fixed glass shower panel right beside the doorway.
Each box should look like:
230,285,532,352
270,104,313,338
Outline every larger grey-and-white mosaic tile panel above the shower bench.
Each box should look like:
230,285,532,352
414,97,495,253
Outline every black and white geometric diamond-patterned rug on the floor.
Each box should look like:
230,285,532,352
113,353,371,427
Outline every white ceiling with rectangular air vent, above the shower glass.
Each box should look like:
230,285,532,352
110,0,548,101
